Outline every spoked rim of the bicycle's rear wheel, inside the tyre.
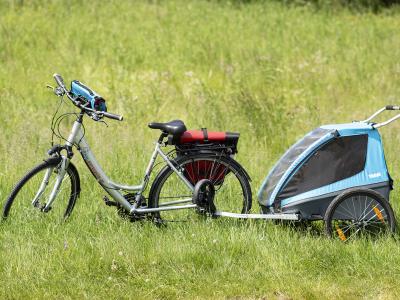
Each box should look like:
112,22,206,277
155,157,249,219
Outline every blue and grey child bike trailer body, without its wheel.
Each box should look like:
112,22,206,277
258,122,392,219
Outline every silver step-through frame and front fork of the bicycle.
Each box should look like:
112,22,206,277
50,113,197,214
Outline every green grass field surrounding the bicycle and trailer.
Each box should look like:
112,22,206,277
0,0,400,299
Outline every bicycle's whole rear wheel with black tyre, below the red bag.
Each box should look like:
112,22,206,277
149,154,252,219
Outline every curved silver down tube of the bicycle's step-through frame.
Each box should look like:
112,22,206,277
76,131,133,211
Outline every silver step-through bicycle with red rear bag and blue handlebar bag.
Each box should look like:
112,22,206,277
2,74,252,222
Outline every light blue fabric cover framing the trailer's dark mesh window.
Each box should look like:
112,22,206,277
258,123,389,207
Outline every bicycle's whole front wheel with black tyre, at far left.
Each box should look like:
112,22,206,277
3,158,80,222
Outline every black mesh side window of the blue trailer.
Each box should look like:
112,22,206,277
276,134,368,203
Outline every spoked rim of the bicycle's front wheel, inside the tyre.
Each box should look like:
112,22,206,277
7,166,76,222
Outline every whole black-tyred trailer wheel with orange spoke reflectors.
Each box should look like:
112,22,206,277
324,189,396,242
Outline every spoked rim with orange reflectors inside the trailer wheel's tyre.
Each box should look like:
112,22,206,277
331,195,391,242
